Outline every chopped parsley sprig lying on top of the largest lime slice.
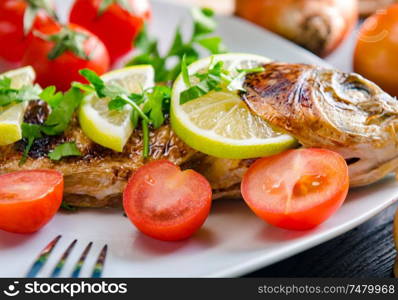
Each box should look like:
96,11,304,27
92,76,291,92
180,57,264,104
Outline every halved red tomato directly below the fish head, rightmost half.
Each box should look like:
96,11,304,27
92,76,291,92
241,149,349,230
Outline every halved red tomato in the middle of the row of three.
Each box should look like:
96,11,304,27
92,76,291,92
123,160,212,241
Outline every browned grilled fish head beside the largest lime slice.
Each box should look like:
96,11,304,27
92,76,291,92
242,63,398,186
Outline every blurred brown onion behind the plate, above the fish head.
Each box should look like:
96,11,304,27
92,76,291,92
236,0,358,56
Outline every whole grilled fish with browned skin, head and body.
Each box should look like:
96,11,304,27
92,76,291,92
0,63,398,207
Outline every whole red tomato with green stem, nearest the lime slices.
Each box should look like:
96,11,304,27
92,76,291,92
22,24,109,91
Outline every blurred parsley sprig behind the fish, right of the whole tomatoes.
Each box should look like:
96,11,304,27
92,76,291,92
127,8,226,82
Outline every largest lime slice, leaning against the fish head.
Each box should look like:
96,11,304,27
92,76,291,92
171,53,296,159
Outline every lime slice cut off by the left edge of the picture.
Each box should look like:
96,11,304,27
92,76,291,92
0,67,36,146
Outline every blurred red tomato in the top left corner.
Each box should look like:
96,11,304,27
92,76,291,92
0,0,56,63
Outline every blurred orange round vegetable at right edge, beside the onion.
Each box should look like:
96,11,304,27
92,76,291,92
354,4,398,96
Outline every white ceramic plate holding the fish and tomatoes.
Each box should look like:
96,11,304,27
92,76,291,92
0,0,398,277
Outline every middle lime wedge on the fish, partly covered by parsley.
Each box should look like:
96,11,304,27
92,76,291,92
79,65,155,152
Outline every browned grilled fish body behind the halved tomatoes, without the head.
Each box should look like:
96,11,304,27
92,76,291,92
0,102,245,207
